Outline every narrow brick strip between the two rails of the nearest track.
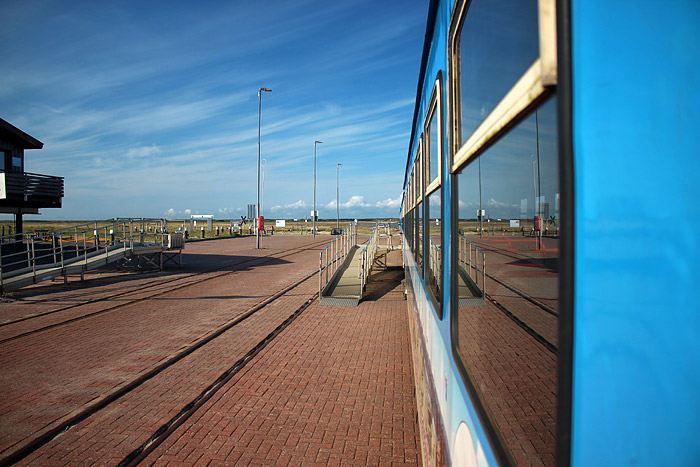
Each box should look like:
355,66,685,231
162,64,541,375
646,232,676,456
18,277,318,465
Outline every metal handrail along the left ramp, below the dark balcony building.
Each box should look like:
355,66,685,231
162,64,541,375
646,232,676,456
0,219,167,286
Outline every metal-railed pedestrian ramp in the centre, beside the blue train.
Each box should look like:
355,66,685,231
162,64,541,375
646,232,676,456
319,223,400,306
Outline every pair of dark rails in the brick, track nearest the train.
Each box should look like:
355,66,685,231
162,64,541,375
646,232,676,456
0,254,318,465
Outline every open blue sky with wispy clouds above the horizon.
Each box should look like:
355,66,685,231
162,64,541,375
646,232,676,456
0,0,428,220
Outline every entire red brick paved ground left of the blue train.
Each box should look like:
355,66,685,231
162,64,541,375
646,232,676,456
0,236,420,465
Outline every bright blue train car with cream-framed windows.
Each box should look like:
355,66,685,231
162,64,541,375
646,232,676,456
401,0,700,466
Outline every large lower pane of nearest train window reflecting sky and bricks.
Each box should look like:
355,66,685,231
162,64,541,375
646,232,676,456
453,97,560,465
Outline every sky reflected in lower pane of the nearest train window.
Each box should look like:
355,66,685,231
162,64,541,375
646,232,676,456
457,98,559,219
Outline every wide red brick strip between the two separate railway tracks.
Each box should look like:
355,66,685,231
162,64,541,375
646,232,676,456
0,237,326,462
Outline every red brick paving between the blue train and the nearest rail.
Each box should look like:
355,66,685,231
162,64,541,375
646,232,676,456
139,272,420,465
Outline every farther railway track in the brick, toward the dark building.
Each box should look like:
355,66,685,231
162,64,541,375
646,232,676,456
0,242,326,345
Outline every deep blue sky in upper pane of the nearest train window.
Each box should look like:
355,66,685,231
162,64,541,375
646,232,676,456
460,0,539,143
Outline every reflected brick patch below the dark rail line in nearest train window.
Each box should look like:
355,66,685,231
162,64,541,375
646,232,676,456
459,303,557,465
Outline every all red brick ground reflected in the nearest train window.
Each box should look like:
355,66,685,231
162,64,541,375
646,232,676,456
458,236,559,465
